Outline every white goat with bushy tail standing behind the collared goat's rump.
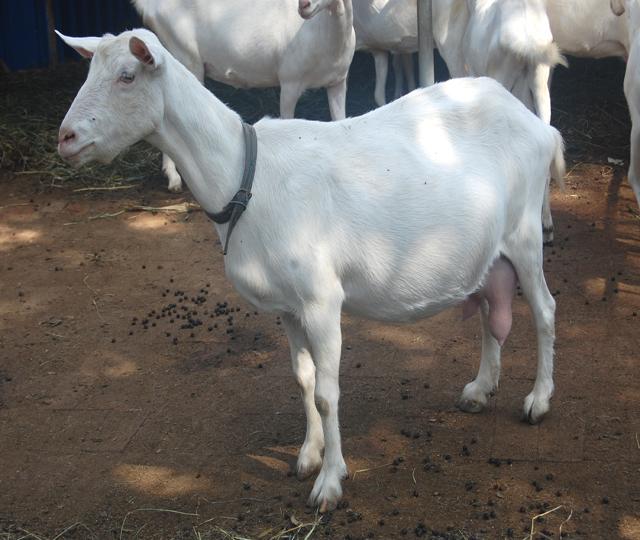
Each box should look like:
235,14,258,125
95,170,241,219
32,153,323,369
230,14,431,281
433,0,564,241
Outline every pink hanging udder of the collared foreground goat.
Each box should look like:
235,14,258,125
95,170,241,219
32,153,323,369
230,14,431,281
462,257,518,346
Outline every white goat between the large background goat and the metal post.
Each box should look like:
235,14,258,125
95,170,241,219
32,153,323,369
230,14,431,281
353,0,418,106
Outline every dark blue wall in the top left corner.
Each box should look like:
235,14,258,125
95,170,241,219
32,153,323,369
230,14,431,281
0,0,142,70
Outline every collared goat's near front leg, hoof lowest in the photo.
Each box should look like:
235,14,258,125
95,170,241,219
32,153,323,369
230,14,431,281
303,301,347,512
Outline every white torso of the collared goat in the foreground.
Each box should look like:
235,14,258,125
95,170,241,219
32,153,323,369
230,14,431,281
226,79,557,321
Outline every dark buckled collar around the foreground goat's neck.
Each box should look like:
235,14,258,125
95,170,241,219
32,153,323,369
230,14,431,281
205,122,258,255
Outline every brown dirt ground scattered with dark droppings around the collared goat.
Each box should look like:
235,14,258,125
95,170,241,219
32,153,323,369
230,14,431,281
0,52,640,540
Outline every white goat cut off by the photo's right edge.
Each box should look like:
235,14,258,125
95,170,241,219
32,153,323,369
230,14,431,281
611,0,640,204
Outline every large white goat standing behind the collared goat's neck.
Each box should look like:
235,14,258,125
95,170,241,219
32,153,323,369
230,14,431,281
133,0,355,191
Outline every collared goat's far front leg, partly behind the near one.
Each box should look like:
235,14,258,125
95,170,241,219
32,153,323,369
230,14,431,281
282,315,324,480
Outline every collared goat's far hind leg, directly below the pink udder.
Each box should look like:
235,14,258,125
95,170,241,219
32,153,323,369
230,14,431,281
458,298,501,413
